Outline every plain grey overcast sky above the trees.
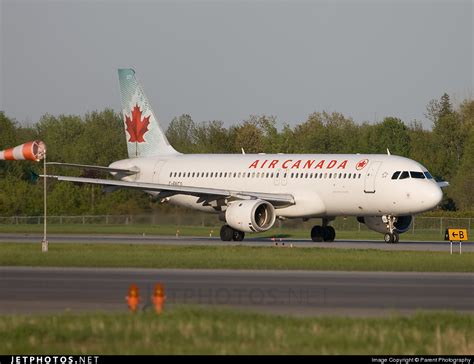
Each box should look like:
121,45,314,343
0,0,474,127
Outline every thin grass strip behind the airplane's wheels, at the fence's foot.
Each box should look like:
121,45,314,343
0,224,460,241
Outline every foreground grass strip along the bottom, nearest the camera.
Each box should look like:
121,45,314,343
0,306,474,354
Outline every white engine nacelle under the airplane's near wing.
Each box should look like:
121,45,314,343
225,200,276,232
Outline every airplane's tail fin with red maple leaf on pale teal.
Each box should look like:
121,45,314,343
118,68,178,158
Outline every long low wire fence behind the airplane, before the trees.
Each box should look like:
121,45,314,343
0,213,474,235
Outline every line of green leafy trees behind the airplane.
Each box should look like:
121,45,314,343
0,94,474,216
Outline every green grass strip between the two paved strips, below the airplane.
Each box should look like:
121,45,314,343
0,242,474,272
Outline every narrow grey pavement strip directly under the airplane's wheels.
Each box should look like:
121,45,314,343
0,233,474,252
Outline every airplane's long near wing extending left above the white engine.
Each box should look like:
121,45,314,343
41,175,295,208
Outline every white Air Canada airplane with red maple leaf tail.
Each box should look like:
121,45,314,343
45,68,448,243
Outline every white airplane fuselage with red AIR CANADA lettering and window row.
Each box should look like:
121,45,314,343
110,154,442,218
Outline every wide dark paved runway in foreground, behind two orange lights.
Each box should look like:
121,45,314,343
0,267,474,316
